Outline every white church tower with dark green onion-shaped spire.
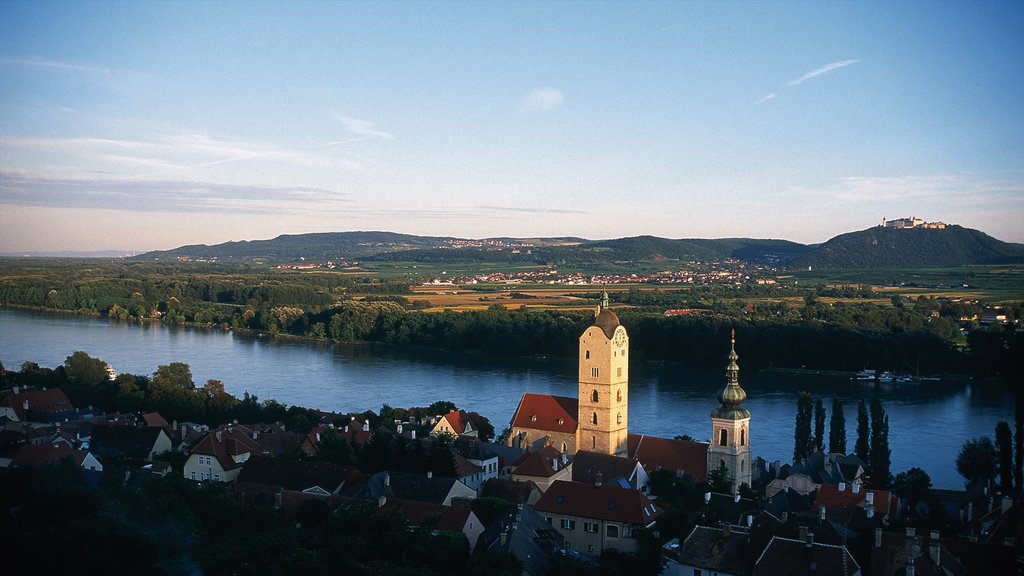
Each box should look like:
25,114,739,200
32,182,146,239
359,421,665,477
708,330,751,493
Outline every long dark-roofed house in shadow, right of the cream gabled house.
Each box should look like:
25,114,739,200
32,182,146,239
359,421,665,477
232,454,365,507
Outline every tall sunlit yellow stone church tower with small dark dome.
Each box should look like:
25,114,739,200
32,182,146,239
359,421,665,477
577,292,630,456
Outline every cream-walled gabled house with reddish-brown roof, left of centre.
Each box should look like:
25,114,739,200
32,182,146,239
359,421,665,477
182,425,260,482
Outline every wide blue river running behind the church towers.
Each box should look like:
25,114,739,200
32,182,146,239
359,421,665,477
0,308,1014,488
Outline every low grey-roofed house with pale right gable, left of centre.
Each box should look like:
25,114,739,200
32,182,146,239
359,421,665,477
342,471,476,506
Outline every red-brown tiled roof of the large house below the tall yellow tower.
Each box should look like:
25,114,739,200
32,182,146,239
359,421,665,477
534,480,662,526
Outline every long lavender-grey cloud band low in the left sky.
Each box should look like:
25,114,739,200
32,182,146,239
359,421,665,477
0,170,349,214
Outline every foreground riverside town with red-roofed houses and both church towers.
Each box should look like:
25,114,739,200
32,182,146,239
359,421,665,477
0,297,1024,576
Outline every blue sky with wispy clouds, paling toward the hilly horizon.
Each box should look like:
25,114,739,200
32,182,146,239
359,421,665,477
0,0,1024,252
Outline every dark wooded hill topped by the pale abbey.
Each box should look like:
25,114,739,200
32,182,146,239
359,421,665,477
791,225,1024,269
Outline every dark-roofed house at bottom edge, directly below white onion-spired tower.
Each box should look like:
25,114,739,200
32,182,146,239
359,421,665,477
662,524,754,576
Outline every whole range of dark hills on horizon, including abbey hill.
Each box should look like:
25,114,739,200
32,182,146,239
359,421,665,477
134,225,1024,269
